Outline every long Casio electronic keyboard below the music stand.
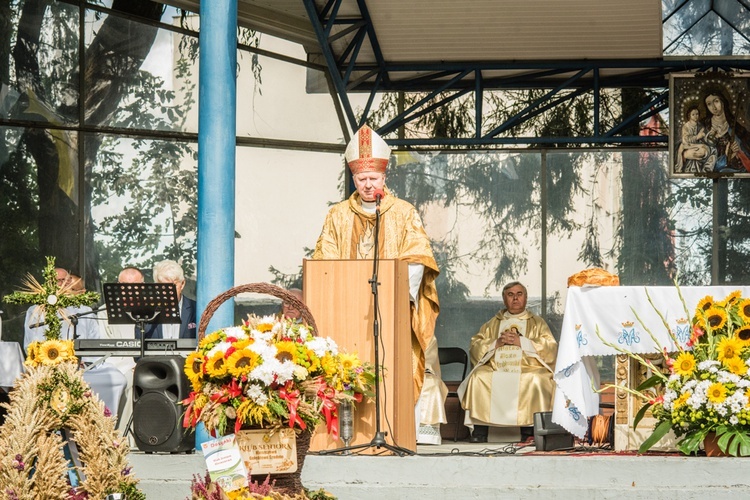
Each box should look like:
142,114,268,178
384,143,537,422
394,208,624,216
74,339,198,357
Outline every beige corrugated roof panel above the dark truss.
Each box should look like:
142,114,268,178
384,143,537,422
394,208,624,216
370,0,662,62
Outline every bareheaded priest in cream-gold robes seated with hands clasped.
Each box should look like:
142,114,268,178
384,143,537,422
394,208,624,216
458,281,557,443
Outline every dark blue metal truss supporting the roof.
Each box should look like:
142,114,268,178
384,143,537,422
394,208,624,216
302,0,750,147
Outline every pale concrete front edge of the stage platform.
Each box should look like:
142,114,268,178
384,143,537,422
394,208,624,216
130,441,750,500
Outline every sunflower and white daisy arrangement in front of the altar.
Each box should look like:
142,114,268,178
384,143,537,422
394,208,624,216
633,291,750,456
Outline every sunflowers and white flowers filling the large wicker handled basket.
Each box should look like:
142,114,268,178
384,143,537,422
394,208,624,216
182,315,375,437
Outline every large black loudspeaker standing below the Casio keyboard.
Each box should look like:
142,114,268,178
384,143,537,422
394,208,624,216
133,356,195,453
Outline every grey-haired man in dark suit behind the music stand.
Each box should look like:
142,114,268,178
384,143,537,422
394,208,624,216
145,260,197,339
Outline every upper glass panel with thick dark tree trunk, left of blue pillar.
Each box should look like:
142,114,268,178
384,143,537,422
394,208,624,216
84,5,198,132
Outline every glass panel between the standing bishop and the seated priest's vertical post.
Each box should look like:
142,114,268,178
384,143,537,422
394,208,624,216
386,151,542,360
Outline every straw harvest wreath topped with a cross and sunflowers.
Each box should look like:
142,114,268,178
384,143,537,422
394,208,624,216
0,257,145,500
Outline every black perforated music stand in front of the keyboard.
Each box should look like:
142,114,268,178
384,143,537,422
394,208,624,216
104,283,180,357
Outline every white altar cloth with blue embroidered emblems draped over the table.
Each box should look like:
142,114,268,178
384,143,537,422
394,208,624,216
552,286,750,438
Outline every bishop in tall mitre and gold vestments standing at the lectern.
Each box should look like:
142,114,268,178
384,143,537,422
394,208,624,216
313,125,447,444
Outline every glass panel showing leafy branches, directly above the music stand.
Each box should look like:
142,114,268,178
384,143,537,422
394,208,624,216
86,135,198,294
